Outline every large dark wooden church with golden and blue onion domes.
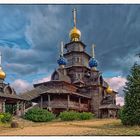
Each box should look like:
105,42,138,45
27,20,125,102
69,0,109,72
21,9,119,118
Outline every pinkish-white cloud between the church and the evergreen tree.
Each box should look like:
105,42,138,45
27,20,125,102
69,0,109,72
105,76,126,105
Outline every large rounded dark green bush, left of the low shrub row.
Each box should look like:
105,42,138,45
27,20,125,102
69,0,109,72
24,108,55,122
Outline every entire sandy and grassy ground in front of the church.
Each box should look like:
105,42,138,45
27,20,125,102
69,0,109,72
0,119,140,136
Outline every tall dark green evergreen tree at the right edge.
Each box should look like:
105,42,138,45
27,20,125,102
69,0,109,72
121,63,140,125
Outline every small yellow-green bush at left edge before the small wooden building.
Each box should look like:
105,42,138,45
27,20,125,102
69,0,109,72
0,113,12,123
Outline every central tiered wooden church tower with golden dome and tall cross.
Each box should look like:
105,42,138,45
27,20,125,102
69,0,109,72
64,9,91,85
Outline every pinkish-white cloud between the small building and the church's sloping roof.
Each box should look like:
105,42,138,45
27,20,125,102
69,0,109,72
11,79,33,94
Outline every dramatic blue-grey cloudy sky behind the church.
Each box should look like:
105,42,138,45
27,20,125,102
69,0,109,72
0,5,140,103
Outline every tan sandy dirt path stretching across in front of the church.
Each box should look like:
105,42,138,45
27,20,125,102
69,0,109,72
0,120,117,136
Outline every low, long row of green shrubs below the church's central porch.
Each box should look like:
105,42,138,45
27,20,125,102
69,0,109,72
59,111,93,121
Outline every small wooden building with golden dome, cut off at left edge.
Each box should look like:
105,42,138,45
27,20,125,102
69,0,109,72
0,54,26,116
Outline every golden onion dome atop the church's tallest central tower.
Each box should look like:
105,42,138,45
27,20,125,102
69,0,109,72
69,26,81,41
